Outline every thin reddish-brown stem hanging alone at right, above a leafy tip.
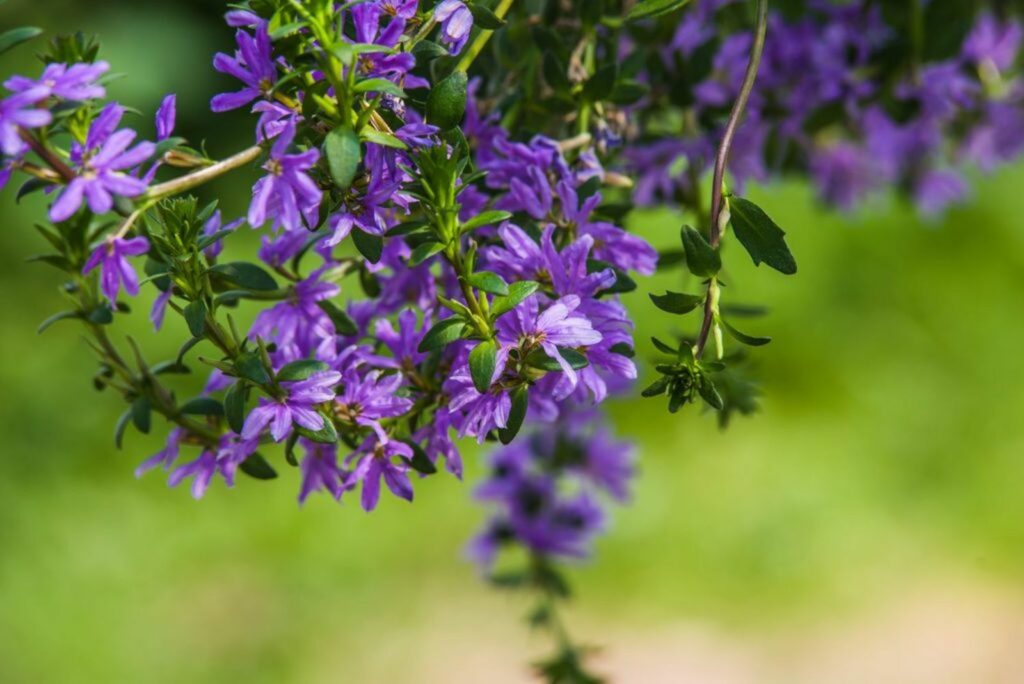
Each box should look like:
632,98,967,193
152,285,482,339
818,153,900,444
693,0,768,359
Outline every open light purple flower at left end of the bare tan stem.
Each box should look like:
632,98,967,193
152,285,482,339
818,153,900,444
50,103,156,222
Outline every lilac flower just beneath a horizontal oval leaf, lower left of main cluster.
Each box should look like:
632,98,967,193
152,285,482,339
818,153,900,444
242,371,341,441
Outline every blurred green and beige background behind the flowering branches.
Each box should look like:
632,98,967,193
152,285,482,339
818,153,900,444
0,0,1024,684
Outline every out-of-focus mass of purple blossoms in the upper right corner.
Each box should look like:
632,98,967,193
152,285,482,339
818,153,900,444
626,0,1024,215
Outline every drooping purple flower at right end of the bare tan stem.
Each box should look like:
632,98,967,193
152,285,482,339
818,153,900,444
249,122,324,230
